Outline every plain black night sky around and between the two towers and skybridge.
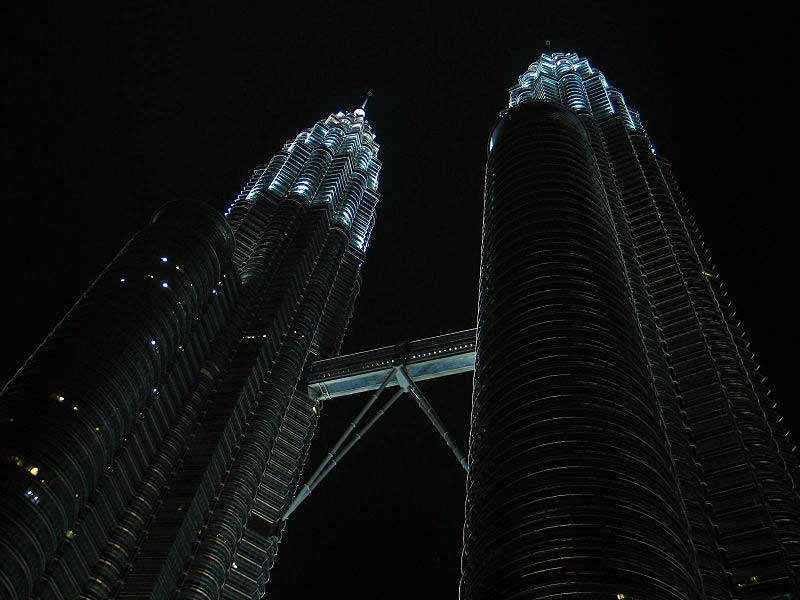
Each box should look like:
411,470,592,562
0,2,800,599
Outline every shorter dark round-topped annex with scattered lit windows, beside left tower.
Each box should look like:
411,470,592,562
0,203,236,598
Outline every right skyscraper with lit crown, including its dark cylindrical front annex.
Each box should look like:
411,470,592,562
461,53,800,600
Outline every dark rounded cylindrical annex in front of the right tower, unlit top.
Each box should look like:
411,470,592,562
462,103,700,599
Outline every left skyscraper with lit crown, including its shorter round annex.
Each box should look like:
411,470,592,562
0,107,381,598
